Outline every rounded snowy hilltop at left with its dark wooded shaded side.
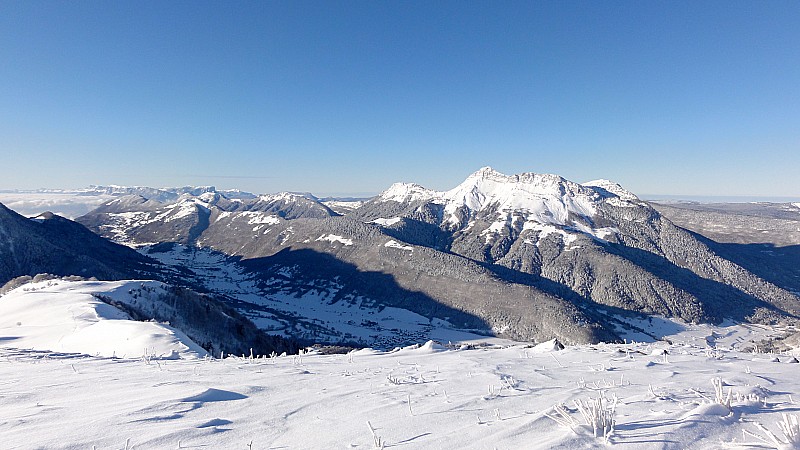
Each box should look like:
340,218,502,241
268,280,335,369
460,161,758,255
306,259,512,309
0,274,299,359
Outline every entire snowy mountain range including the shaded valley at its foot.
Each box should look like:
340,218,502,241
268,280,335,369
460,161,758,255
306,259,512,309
51,168,800,345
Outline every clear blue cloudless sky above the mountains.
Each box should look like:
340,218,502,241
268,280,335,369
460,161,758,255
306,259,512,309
0,0,800,198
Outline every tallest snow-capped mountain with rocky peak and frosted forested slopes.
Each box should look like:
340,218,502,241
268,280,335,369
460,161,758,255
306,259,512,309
354,168,798,321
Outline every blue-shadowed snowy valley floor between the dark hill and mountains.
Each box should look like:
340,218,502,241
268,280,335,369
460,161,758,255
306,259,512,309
140,246,488,348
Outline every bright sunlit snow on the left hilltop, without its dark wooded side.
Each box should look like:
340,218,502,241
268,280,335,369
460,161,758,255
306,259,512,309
0,280,206,358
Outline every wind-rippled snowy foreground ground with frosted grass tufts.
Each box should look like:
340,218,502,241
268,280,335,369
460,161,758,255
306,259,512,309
0,327,800,449
